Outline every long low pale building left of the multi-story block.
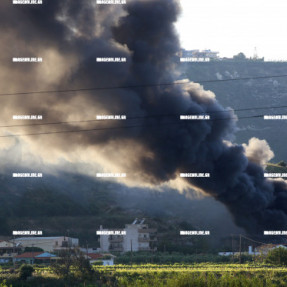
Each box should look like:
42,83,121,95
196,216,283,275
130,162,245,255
12,236,79,252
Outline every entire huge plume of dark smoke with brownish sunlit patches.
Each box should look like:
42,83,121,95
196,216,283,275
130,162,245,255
0,0,287,232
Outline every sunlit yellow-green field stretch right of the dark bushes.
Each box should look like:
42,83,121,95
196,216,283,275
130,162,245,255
93,263,287,287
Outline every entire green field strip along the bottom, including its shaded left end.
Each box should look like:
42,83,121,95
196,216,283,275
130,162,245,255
0,263,287,287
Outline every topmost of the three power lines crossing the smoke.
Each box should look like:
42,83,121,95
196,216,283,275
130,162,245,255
0,74,287,97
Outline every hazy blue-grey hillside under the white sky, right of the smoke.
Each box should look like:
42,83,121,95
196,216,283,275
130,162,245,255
182,61,287,162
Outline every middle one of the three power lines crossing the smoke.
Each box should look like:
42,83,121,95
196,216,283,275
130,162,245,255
0,105,287,128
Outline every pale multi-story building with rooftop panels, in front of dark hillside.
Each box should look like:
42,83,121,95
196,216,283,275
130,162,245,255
100,219,157,252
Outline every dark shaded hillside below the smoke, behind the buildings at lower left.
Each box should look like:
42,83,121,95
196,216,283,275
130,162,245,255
0,169,243,246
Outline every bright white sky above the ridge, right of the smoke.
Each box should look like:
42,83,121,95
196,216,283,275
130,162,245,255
176,0,287,60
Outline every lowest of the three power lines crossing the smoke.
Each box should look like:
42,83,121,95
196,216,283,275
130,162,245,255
0,115,276,138
